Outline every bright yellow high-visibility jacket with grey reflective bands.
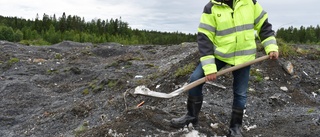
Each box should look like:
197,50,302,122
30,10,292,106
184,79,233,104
197,0,278,75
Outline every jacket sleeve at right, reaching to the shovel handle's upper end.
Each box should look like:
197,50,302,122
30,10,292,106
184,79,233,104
254,1,278,54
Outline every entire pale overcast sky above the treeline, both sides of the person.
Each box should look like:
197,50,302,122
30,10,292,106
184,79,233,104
0,0,320,33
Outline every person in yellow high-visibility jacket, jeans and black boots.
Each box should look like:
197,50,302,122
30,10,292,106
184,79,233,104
171,0,279,136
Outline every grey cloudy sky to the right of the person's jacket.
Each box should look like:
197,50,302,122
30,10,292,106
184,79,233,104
258,0,320,30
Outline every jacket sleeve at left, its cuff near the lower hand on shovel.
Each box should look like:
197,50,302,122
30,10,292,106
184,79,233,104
197,2,217,75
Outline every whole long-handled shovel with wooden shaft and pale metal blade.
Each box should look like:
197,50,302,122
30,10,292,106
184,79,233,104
134,55,269,98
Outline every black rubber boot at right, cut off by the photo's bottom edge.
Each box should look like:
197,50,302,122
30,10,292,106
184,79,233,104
227,108,243,137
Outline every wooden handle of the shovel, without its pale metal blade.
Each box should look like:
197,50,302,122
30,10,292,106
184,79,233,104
183,55,269,91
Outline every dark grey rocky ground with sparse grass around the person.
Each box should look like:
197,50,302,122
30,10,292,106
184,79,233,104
0,41,320,137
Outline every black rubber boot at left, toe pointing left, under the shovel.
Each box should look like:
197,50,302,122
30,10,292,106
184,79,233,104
171,96,203,128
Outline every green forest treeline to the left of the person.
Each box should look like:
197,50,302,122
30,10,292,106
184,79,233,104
0,13,196,45
